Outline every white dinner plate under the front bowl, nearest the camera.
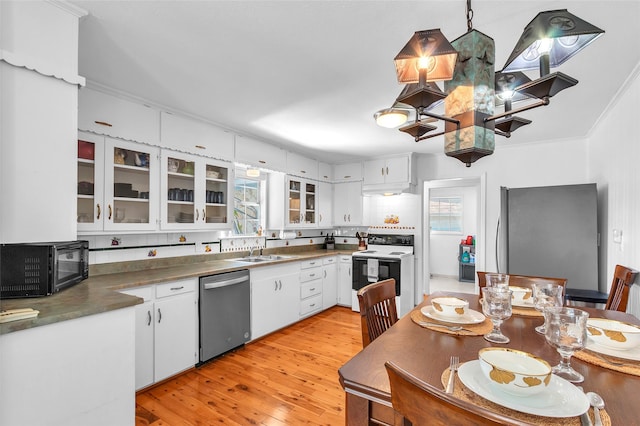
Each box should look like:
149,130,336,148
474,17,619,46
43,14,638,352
458,360,590,417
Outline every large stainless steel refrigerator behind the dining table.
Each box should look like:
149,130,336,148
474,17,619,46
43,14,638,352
496,183,599,291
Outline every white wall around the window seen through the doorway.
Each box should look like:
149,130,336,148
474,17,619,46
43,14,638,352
425,186,478,277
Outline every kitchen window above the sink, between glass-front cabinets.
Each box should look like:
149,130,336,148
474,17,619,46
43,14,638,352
233,169,266,235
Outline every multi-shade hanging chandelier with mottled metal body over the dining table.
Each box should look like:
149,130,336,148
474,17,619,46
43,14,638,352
374,0,604,167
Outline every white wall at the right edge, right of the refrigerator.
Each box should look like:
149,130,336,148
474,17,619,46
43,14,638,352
588,65,640,317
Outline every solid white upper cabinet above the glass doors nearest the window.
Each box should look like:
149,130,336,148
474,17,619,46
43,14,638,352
160,112,234,161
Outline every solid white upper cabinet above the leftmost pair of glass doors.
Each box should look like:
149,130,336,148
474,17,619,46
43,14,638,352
78,87,160,145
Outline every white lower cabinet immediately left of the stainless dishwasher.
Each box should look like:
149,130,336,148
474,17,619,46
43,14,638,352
121,278,198,389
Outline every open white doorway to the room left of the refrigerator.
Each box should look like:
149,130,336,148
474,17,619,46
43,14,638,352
422,174,486,294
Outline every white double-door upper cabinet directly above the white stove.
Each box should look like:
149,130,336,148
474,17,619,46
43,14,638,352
362,155,415,192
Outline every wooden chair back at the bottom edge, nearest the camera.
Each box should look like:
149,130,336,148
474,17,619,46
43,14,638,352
384,361,530,426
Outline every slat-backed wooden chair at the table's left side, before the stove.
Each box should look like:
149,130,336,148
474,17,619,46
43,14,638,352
357,278,398,347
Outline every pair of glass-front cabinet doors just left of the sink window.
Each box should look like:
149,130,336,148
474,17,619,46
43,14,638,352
160,150,233,229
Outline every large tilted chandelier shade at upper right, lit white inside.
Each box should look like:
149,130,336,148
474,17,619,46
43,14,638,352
502,9,604,72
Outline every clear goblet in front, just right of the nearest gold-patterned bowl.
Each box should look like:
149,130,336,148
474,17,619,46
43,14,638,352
544,307,589,383
